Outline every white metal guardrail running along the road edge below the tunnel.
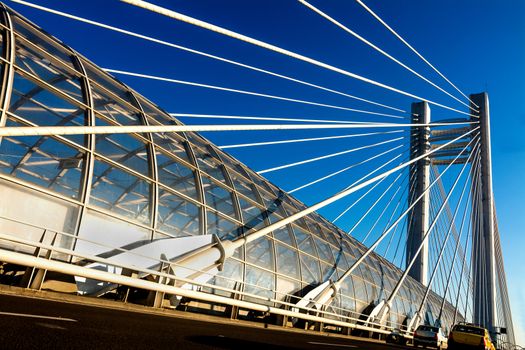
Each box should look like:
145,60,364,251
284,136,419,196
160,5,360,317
0,216,411,337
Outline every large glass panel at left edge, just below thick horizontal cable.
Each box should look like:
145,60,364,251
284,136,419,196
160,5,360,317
0,121,85,199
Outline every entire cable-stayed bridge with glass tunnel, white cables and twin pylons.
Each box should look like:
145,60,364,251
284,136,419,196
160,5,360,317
0,0,515,347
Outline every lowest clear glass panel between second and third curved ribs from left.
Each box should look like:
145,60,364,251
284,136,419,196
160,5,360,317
90,159,151,224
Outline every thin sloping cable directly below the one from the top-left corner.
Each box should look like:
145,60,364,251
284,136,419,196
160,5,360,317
102,68,405,119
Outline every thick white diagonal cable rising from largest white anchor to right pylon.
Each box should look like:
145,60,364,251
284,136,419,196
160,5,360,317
227,126,479,250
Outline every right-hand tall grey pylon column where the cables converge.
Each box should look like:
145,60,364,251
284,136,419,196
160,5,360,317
470,92,496,334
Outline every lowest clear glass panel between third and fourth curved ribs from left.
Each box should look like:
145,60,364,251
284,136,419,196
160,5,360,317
157,188,200,236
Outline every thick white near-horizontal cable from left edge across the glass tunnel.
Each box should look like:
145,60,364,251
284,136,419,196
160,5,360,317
0,120,478,138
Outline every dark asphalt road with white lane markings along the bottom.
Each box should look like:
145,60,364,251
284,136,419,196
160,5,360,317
0,295,410,350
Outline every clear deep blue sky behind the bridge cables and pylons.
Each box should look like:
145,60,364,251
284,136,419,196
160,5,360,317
7,0,525,344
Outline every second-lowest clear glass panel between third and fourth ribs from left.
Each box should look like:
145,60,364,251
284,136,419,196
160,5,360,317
157,152,198,200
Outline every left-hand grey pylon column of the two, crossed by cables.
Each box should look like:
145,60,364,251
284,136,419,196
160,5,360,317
406,102,430,285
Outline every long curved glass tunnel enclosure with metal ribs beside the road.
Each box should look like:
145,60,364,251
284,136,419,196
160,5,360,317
0,3,462,329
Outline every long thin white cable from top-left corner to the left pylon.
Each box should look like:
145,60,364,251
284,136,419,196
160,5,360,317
12,0,408,113
